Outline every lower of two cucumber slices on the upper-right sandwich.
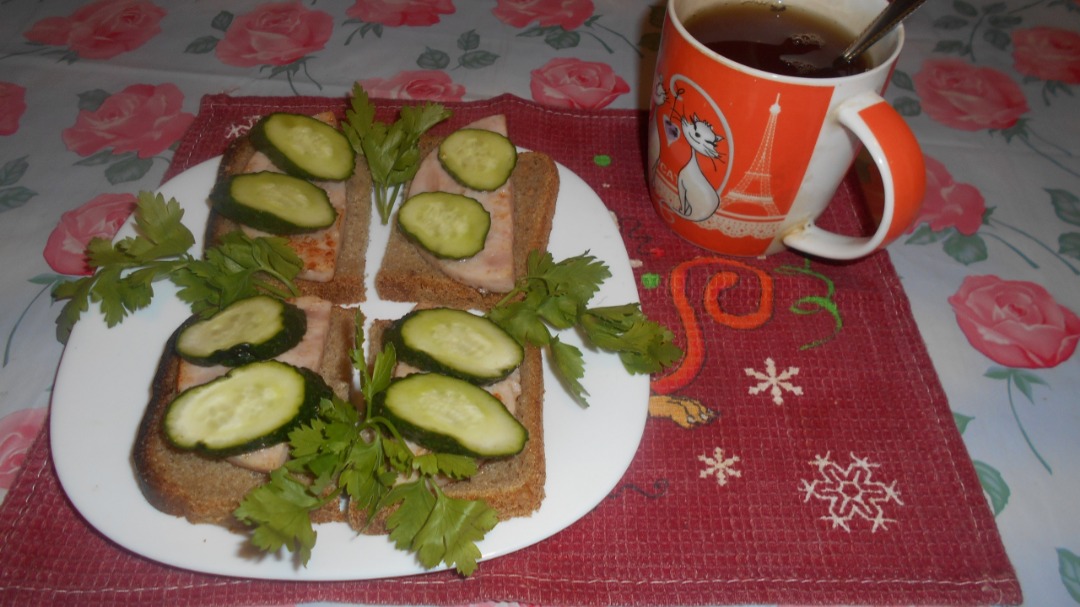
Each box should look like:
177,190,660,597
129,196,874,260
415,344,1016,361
397,192,491,259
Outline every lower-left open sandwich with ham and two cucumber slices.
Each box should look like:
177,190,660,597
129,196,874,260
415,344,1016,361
132,296,354,528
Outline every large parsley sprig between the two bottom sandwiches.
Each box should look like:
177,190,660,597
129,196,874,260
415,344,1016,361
234,312,498,576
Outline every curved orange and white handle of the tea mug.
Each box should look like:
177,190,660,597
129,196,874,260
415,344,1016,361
783,92,927,259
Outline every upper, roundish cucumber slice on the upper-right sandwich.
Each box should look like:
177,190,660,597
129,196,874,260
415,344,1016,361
438,129,517,191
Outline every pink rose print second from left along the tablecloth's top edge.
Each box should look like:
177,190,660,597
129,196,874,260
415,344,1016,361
214,2,334,67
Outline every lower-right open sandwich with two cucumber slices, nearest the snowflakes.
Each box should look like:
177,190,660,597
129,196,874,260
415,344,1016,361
348,308,546,534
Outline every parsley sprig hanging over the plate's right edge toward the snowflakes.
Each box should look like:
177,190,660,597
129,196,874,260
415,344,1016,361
487,251,683,406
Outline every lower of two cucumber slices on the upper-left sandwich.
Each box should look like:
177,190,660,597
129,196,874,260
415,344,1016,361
211,172,337,234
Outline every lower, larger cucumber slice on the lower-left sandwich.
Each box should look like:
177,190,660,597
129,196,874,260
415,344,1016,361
164,361,333,457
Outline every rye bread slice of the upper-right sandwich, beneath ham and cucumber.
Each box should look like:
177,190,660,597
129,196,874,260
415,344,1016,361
375,137,559,310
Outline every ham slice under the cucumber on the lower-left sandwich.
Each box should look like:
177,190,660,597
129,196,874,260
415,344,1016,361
176,296,333,472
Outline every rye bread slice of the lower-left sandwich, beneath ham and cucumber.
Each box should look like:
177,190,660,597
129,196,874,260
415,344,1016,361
132,306,355,529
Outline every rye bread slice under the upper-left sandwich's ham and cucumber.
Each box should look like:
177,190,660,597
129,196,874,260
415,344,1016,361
204,114,372,305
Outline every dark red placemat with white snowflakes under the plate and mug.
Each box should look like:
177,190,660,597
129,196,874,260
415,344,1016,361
0,96,1021,606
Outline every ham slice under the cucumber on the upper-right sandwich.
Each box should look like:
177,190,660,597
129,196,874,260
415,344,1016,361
408,114,514,293
